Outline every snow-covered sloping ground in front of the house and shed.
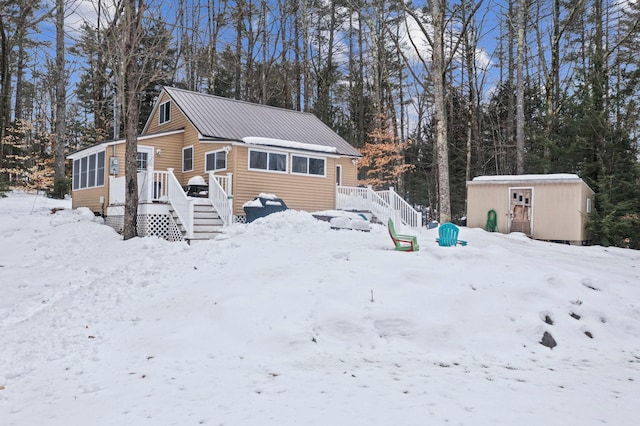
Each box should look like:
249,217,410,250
0,193,640,426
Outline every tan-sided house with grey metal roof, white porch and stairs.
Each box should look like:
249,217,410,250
68,87,420,240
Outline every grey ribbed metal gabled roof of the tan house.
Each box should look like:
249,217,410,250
151,87,361,157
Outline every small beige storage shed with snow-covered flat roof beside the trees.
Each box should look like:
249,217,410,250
467,174,594,244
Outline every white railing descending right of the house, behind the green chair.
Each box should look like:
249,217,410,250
336,186,422,230
